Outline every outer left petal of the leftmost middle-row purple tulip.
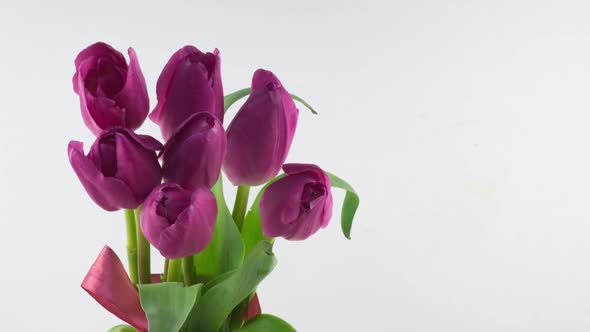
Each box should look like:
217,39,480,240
68,141,139,211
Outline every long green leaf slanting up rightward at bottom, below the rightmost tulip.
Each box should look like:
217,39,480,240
187,242,276,331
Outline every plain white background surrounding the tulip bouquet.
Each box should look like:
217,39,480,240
0,0,590,332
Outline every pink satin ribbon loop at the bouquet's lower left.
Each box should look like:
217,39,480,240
82,246,148,332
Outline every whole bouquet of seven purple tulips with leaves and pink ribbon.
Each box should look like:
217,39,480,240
68,43,359,332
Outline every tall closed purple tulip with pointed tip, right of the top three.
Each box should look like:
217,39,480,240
223,69,299,186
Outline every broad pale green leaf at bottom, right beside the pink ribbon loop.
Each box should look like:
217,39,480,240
139,282,203,332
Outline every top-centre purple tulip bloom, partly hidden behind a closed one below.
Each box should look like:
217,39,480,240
150,46,223,140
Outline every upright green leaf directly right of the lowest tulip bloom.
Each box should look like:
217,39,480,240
194,176,244,278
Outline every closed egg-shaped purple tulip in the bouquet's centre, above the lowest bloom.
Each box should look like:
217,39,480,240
161,112,226,190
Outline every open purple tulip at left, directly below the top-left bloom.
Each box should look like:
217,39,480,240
68,128,162,211
